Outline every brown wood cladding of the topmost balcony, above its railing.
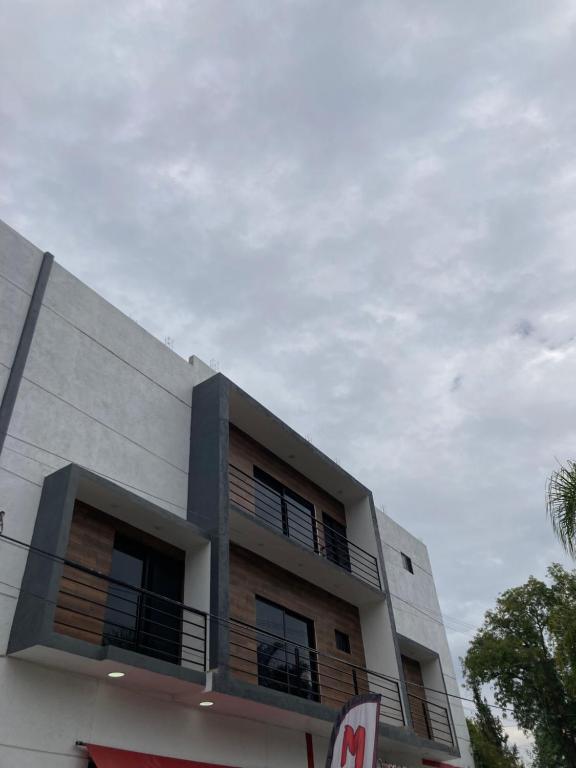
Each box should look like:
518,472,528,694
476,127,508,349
230,425,346,546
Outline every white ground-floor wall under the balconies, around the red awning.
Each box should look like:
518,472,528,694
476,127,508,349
0,659,325,768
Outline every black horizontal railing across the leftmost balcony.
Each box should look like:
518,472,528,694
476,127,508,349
54,561,207,671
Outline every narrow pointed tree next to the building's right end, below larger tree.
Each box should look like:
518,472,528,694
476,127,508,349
466,682,524,768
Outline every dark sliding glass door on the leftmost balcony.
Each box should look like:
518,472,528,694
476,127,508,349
104,533,184,664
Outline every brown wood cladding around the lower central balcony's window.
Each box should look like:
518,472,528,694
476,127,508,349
230,544,368,707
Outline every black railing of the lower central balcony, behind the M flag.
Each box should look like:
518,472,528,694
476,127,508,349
229,620,405,726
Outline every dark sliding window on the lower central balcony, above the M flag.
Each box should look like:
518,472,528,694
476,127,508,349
256,597,319,701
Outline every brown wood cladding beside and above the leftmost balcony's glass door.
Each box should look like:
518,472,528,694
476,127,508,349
54,501,184,645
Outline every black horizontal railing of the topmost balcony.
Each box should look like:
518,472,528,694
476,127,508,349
229,464,381,589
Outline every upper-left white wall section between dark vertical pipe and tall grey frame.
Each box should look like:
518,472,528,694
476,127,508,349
3,264,210,516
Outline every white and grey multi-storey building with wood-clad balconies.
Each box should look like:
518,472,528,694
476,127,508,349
0,219,473,768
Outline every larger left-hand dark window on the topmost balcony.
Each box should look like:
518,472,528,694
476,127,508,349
254,467,318,551
